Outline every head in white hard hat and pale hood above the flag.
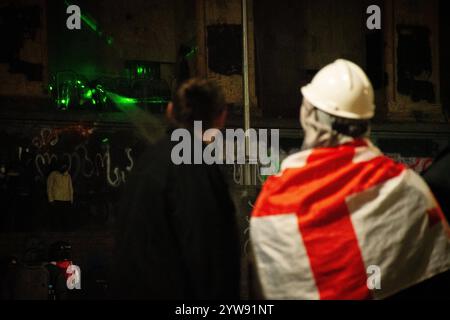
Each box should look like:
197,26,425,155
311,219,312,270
300,59,375,149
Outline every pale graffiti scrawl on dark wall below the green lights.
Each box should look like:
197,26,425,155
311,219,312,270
15,126,134,187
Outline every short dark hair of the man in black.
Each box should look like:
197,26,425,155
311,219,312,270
172,78,225,129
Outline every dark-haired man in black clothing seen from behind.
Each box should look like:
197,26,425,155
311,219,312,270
111,79,240,299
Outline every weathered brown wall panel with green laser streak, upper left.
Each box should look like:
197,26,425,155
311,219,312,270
45,0,178,85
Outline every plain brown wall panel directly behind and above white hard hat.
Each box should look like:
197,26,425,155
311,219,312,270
254,0,366,118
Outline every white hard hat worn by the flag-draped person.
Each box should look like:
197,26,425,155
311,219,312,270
301,59,375,119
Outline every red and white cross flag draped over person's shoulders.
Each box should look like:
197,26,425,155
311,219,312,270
250,140,450,299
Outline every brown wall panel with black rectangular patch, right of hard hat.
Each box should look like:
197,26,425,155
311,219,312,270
386,0,445,122
